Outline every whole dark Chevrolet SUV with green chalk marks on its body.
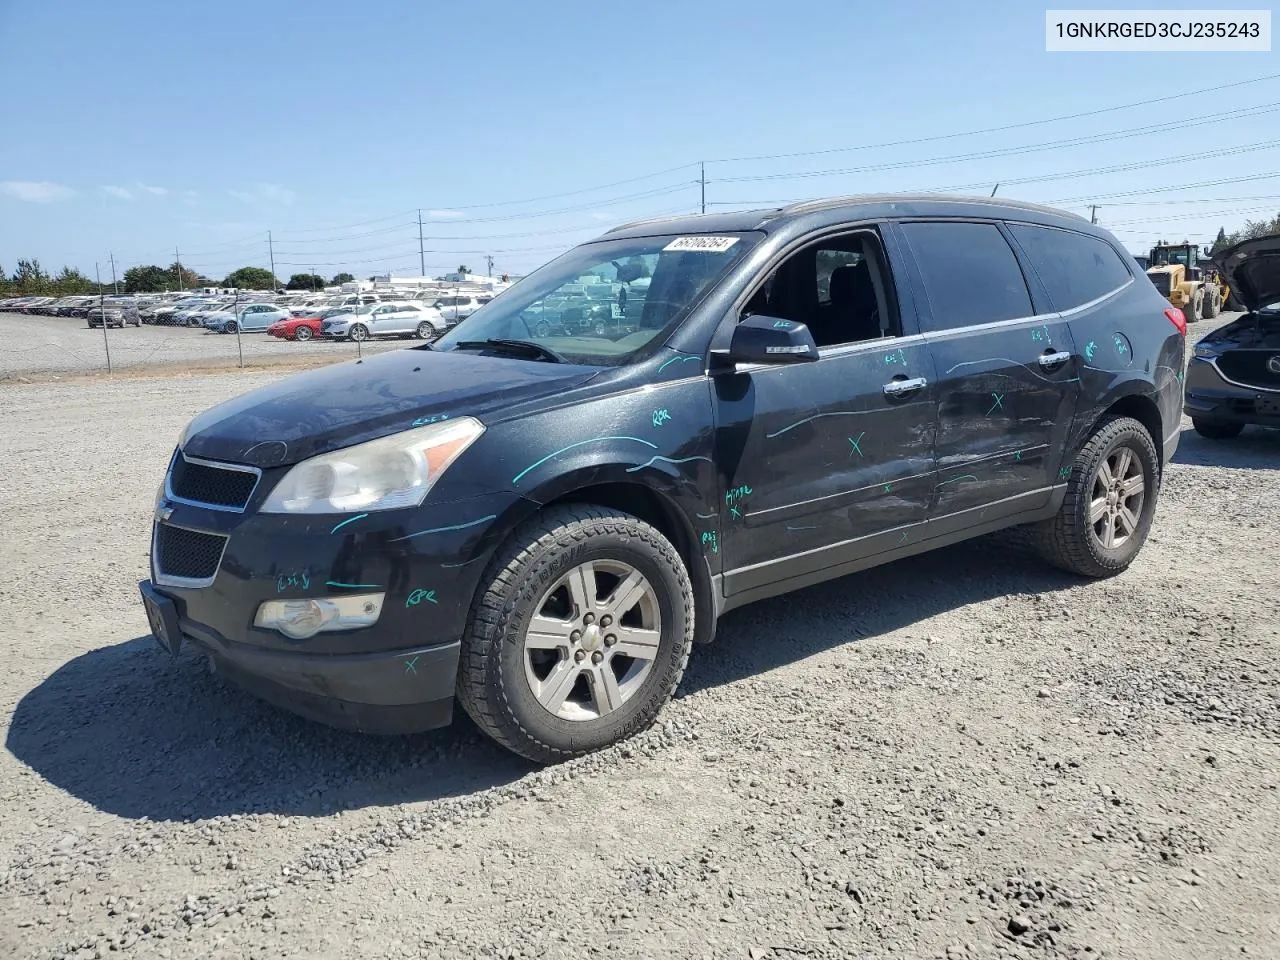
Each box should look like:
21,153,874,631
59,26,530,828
141,196,1187,762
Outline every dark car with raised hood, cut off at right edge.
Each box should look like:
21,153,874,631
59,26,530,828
1185,236,1280,440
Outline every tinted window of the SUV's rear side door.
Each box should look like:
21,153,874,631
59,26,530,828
902,223,1036,330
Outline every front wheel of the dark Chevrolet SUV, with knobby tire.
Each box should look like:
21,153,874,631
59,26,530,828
457,504,694,763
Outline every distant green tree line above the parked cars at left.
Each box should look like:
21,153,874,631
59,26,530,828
0,260,356,297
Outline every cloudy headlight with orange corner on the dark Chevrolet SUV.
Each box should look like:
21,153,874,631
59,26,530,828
261,417,484,513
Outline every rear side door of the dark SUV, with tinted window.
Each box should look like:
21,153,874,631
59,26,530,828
897,220,1080,535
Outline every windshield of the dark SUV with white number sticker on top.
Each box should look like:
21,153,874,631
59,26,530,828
433,233,760,366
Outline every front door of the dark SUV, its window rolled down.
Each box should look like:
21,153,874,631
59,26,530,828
713,229,937,595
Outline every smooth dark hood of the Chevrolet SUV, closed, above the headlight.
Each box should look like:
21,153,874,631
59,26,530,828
183,348,599,467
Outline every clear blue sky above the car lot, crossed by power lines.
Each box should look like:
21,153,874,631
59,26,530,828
0,0,1280,278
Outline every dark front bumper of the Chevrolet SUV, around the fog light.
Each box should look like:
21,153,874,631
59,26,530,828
140,477,512,733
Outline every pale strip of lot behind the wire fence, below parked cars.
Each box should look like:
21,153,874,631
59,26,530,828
0,314,413,381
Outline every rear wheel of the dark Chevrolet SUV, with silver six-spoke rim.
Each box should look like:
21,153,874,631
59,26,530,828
1032,417,1160,577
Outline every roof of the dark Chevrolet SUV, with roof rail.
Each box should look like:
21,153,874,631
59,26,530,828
596,193,1100,239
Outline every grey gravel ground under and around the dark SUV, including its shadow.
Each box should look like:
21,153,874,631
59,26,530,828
0,312,1280,960
